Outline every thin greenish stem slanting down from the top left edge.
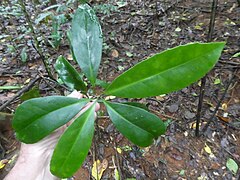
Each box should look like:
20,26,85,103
18,0,54,79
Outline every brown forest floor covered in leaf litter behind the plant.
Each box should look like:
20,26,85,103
0,0,240,180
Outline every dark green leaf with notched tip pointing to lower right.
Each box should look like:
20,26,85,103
104,101,165,147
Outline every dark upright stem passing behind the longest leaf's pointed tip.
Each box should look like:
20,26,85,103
195,0,218,137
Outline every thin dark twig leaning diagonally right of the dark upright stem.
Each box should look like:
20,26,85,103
202,70,238,132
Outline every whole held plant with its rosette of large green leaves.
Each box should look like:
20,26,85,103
12,4,225,178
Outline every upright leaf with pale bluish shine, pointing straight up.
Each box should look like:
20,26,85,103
71,4,103,85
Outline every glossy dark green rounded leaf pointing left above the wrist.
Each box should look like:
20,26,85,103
12,96,89,143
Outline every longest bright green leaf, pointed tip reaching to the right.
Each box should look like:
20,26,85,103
105,42,225,98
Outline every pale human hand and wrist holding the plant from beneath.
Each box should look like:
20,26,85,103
5,91,100,180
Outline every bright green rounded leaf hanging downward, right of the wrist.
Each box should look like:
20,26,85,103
50,104,95,178
